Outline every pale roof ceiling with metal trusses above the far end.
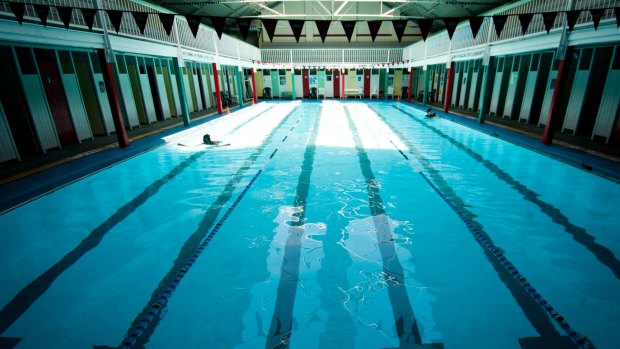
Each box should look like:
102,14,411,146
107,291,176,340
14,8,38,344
151,0,517,48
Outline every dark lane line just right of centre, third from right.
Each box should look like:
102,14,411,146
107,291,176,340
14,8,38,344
344,107,443,348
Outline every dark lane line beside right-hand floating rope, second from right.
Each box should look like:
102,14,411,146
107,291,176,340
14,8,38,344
371,107,594,349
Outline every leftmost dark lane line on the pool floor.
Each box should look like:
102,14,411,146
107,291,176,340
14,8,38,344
0,103,278,334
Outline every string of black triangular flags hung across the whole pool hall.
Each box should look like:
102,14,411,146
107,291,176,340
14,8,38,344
2,1,620,43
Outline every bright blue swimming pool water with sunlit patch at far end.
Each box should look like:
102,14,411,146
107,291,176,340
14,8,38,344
0,101,620,349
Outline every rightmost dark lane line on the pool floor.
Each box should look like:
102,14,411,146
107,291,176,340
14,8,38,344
394,107,620,279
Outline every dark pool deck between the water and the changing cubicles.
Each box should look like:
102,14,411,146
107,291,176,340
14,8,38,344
0,101,620,214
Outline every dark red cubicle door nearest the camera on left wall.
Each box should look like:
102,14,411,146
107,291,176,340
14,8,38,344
34,49,77,145
